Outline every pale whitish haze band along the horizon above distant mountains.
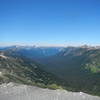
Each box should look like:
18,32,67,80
0,42,100,47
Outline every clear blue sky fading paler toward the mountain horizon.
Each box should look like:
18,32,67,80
0,0,100,45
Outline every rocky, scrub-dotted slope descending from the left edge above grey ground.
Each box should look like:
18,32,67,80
0,51,60,88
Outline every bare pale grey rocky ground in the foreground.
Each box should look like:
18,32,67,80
0,83,100,100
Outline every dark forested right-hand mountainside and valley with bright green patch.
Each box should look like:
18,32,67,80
42,47,100,96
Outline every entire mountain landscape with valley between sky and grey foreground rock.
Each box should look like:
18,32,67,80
0,45,100,96
